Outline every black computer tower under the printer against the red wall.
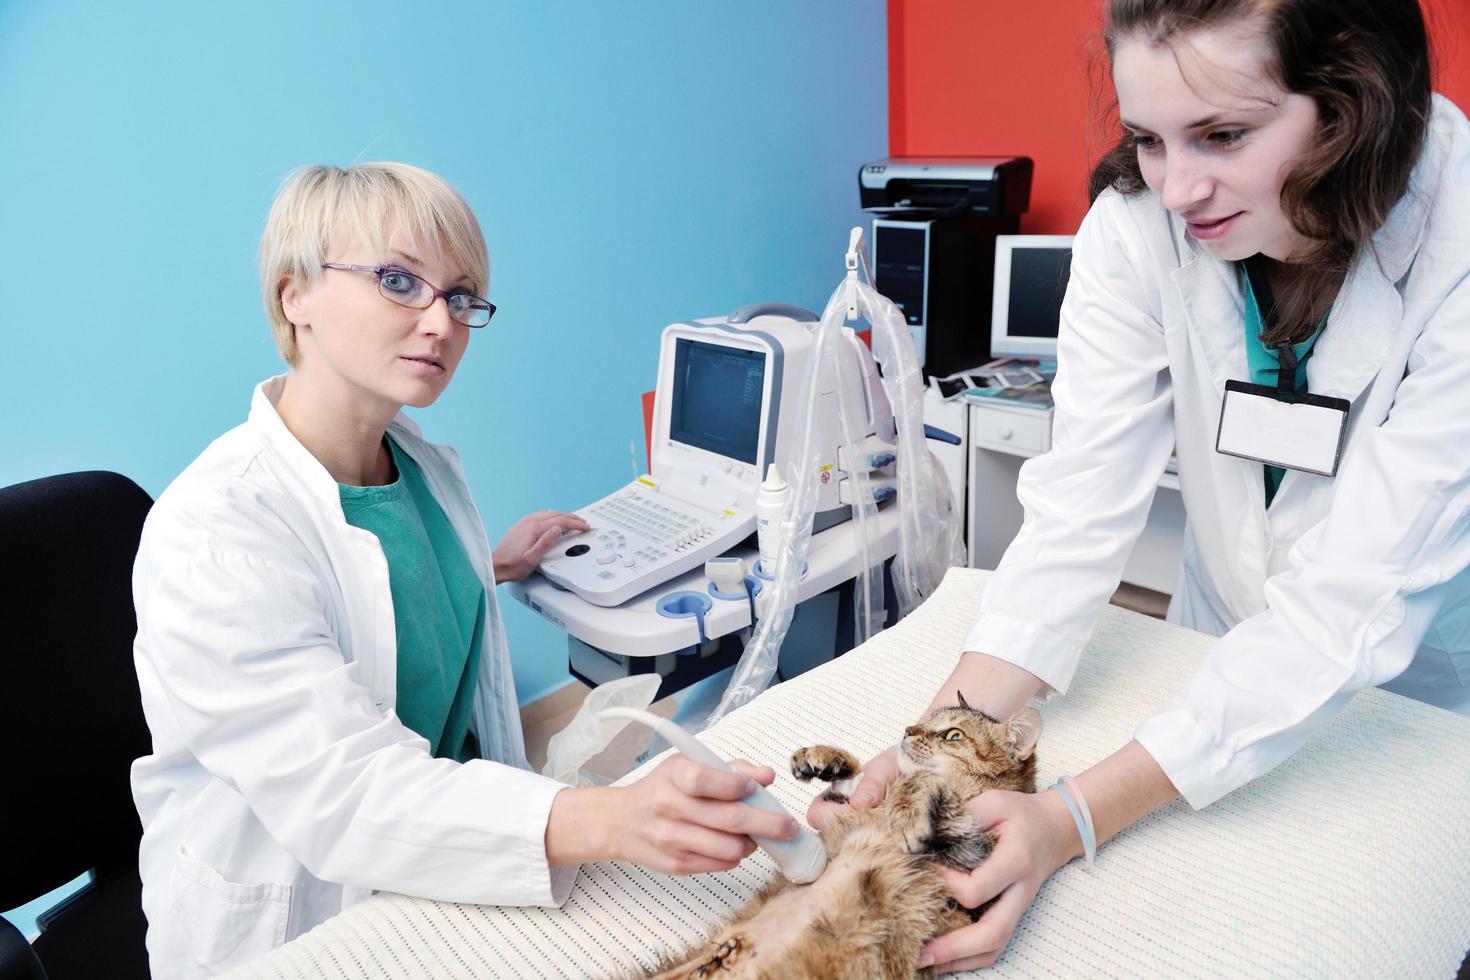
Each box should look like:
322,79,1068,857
873,212,1020,376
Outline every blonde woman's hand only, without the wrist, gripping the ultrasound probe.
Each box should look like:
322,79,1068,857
607,755,797,874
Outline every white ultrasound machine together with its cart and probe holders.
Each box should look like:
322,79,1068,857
509,304,897,693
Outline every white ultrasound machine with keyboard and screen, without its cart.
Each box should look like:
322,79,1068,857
539,304,894,605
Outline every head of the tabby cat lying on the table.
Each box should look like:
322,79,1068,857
898,695,1041,777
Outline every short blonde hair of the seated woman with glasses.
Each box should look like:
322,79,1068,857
260,163,490,364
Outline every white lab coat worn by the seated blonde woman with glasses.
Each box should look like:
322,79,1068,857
132,378,576,980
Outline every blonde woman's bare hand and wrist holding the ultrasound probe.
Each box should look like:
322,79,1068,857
547,755,797,874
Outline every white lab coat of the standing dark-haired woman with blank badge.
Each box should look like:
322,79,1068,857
966,96,1470,807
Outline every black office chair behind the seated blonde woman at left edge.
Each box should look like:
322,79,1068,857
0,473,153,980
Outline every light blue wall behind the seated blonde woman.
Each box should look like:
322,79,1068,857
0,0,886,719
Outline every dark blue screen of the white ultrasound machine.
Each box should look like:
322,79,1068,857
669,338,766,464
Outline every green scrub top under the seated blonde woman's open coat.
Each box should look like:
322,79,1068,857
338,438,485,763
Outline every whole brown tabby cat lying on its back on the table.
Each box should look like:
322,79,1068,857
651,695,1041,980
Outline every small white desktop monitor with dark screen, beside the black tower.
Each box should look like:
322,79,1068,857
991,235,1072,359
